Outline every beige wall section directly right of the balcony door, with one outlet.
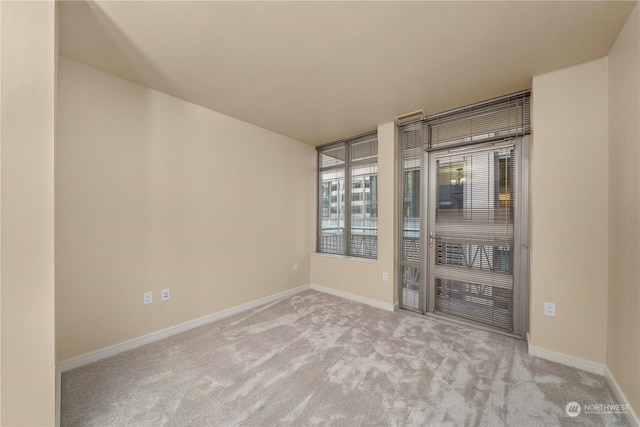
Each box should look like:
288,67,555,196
530,58,609,365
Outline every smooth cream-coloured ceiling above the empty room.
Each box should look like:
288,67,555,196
58,1,636,145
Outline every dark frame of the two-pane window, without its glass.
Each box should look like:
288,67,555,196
316,130,379,260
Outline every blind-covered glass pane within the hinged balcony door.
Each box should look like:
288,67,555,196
427,144,516,333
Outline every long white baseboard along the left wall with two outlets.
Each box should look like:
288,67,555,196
60,285,310,372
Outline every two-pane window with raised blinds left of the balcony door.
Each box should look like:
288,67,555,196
318,132,378,258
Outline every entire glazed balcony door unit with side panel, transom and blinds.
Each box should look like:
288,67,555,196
397,91,531,338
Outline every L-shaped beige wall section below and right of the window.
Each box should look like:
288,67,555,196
310,123,397,304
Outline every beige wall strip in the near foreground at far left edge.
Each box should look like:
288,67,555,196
0,1,56,426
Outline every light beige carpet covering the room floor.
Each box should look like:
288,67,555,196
61,291,627,426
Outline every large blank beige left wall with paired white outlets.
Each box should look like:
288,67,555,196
55,58,316,361
